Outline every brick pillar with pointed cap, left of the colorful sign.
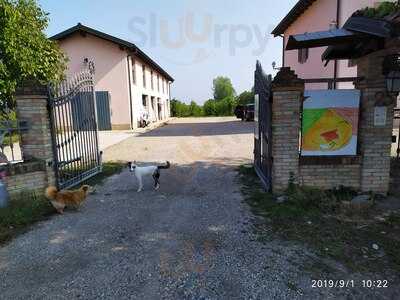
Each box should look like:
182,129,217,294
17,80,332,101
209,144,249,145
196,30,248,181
272,67,304,192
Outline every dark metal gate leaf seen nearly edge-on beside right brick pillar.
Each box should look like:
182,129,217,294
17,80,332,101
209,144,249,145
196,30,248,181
254,61,272,191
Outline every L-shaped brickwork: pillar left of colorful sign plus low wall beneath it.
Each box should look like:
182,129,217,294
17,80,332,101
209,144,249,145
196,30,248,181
272,73,361,192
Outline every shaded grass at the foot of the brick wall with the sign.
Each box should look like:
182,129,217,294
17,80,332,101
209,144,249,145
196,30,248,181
239,166,400,274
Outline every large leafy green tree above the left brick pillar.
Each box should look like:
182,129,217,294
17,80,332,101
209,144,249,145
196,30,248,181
0,0,67,111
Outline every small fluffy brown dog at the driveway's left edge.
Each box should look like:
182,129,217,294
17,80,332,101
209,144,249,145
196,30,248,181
45,185,90,214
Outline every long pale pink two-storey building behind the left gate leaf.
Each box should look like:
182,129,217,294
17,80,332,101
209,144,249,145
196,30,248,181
51,24,174,130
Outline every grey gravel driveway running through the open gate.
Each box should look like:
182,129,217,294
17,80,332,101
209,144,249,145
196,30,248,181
0,118,390,299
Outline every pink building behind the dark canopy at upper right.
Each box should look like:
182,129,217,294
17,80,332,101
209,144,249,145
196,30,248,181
272,0,396,89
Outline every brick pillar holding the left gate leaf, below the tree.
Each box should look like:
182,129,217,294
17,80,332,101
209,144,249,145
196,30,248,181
15,82,55,185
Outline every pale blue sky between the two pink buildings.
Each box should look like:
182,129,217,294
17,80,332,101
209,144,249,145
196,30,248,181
38,0,297,103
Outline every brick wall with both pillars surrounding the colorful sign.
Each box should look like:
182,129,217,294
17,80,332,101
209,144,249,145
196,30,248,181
272,40,399,194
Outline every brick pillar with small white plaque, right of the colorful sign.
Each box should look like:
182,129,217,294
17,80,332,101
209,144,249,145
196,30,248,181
356,47,399,194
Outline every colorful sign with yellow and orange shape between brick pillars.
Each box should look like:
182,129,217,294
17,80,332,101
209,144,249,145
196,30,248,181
301,90,360,156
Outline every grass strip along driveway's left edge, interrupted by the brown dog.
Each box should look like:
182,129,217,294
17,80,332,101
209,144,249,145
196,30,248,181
0,162,124,245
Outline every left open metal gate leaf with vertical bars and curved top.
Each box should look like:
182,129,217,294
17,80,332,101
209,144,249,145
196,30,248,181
49,70,101,189
